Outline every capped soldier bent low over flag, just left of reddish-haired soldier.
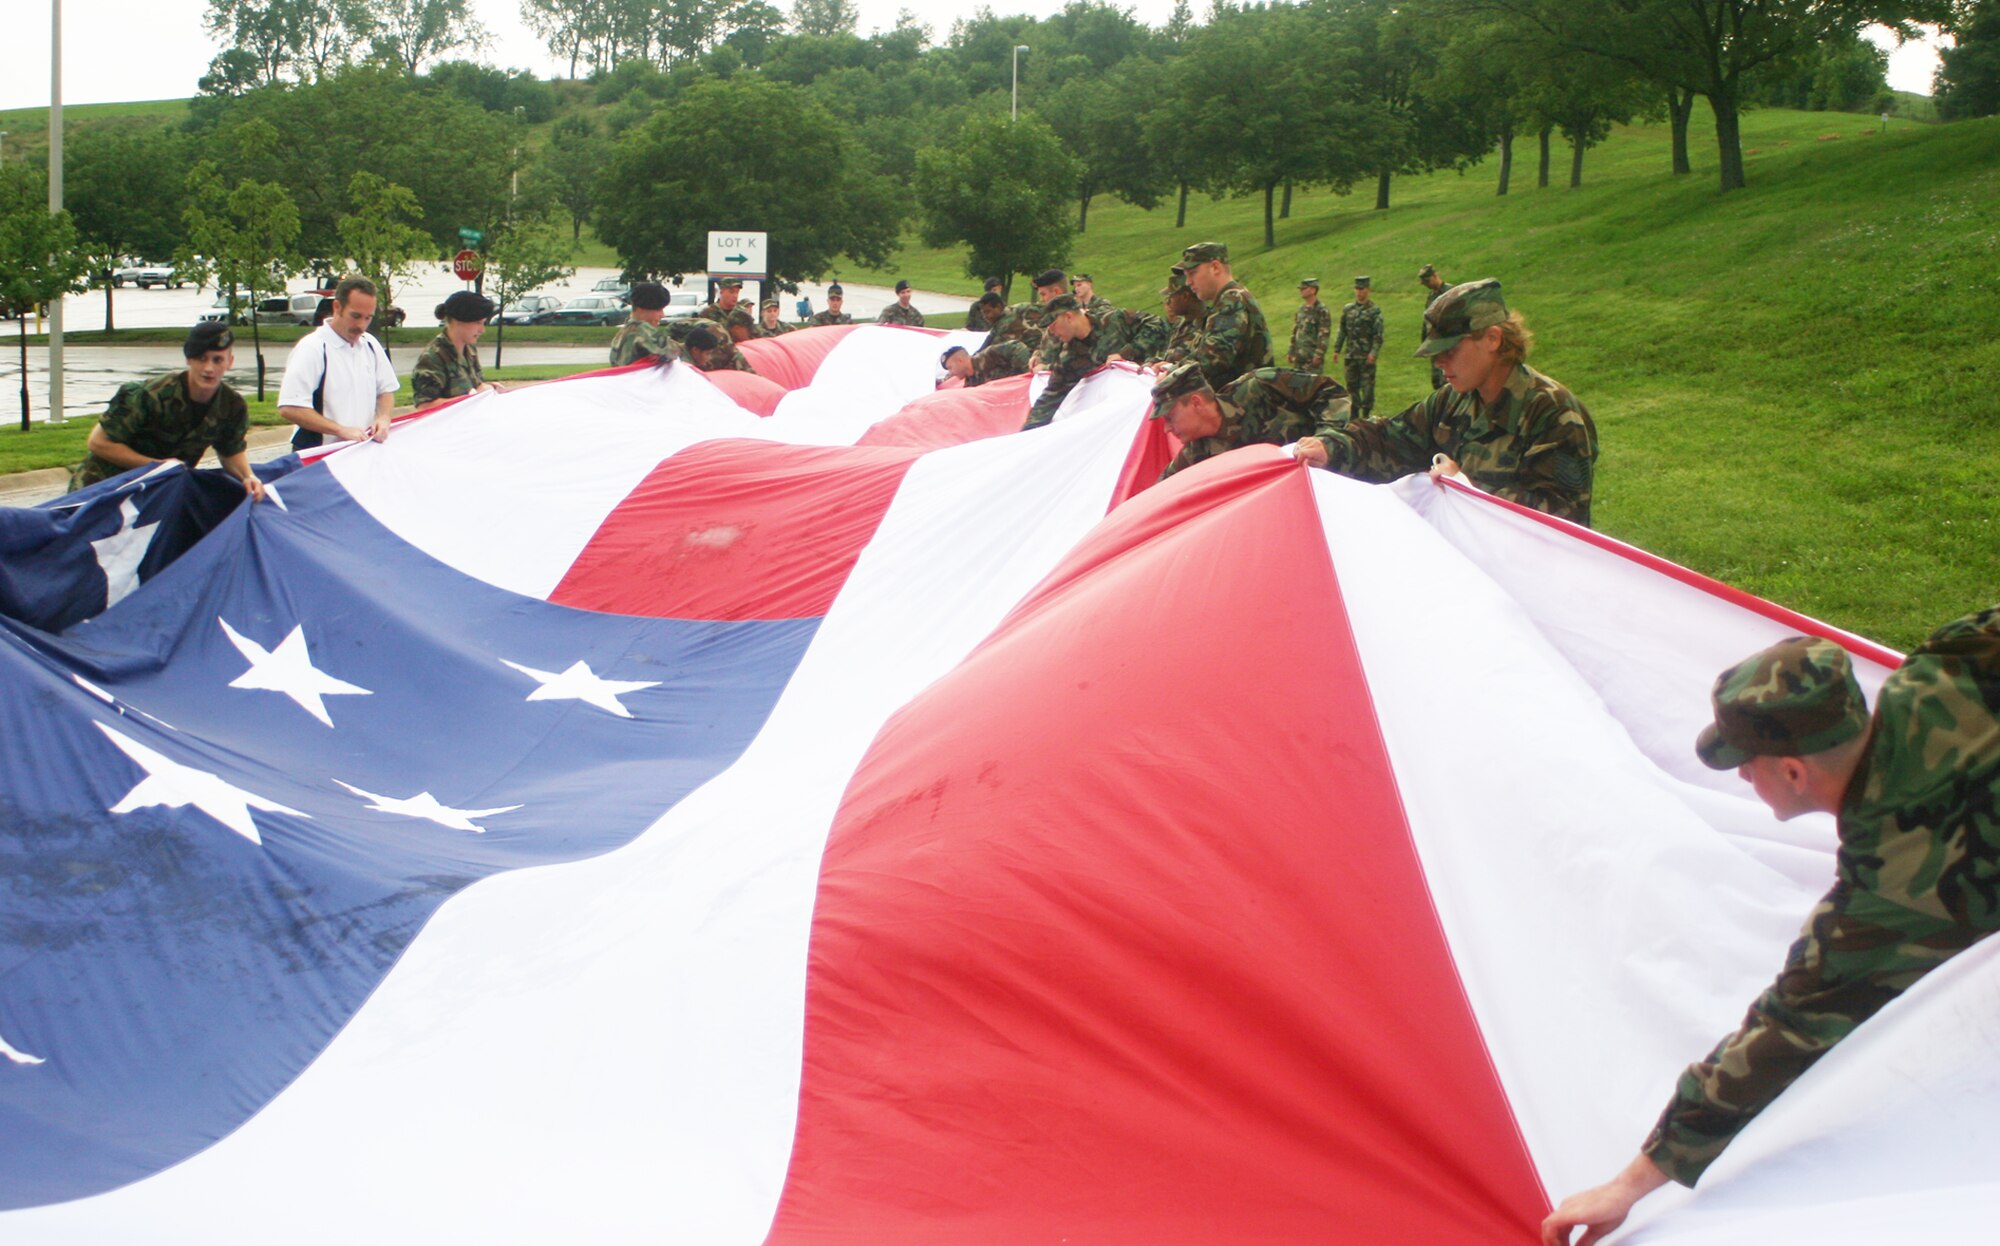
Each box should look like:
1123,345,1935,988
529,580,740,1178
1152,364,1348,480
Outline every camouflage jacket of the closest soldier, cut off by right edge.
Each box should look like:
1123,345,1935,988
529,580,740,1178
1646,606,2000,1186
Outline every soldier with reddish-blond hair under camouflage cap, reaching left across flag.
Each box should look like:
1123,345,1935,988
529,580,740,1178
1298,280,1598,526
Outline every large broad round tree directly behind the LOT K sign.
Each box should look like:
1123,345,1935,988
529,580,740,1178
598,74,904,282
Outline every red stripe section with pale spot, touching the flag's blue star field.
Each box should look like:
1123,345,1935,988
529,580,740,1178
548,440,916,622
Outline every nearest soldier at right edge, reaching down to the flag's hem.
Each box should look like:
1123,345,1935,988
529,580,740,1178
1542,606,2000,1242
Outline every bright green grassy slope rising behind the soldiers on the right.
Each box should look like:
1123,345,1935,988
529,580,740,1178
842,110,2000,648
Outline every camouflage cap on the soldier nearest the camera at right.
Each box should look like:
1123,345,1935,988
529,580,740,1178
1694,636,1868,770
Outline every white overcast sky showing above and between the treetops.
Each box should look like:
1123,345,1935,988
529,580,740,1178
0,0,1936,108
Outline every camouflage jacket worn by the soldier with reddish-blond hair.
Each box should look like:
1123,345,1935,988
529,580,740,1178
1320,364,1598,528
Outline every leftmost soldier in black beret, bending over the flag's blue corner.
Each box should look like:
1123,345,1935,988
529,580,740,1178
70,320,264,502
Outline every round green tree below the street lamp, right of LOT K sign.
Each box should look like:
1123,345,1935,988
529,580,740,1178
914,114,1082,286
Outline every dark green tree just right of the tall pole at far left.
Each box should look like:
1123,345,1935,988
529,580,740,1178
62,124,186,330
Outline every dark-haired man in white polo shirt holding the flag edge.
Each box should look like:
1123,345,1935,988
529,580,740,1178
278,276,396,450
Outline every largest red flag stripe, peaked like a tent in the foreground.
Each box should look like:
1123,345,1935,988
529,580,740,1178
770,456,1546,1246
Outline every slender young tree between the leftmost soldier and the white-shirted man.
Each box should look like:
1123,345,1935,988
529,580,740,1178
174,150,304,402
